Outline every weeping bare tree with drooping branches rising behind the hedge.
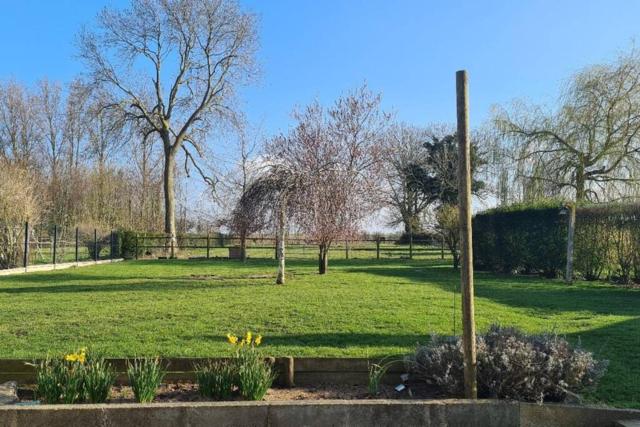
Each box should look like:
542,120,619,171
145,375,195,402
494,51,640,202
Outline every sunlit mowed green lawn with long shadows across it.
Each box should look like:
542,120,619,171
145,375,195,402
0,253,640,407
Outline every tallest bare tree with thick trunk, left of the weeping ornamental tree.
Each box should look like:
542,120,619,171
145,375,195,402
80,0,256,256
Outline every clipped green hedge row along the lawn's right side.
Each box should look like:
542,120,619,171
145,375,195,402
473,201,640,283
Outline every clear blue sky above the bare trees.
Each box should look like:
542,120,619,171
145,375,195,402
0,0,640,134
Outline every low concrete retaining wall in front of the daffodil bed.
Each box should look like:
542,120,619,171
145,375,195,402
0,400,640,427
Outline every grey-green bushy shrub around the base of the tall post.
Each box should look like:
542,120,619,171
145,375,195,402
410,326,607,402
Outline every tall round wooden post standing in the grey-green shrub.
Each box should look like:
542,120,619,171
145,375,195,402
456,70,478,399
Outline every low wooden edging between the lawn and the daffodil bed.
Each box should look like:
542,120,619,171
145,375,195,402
0,357,405,386
